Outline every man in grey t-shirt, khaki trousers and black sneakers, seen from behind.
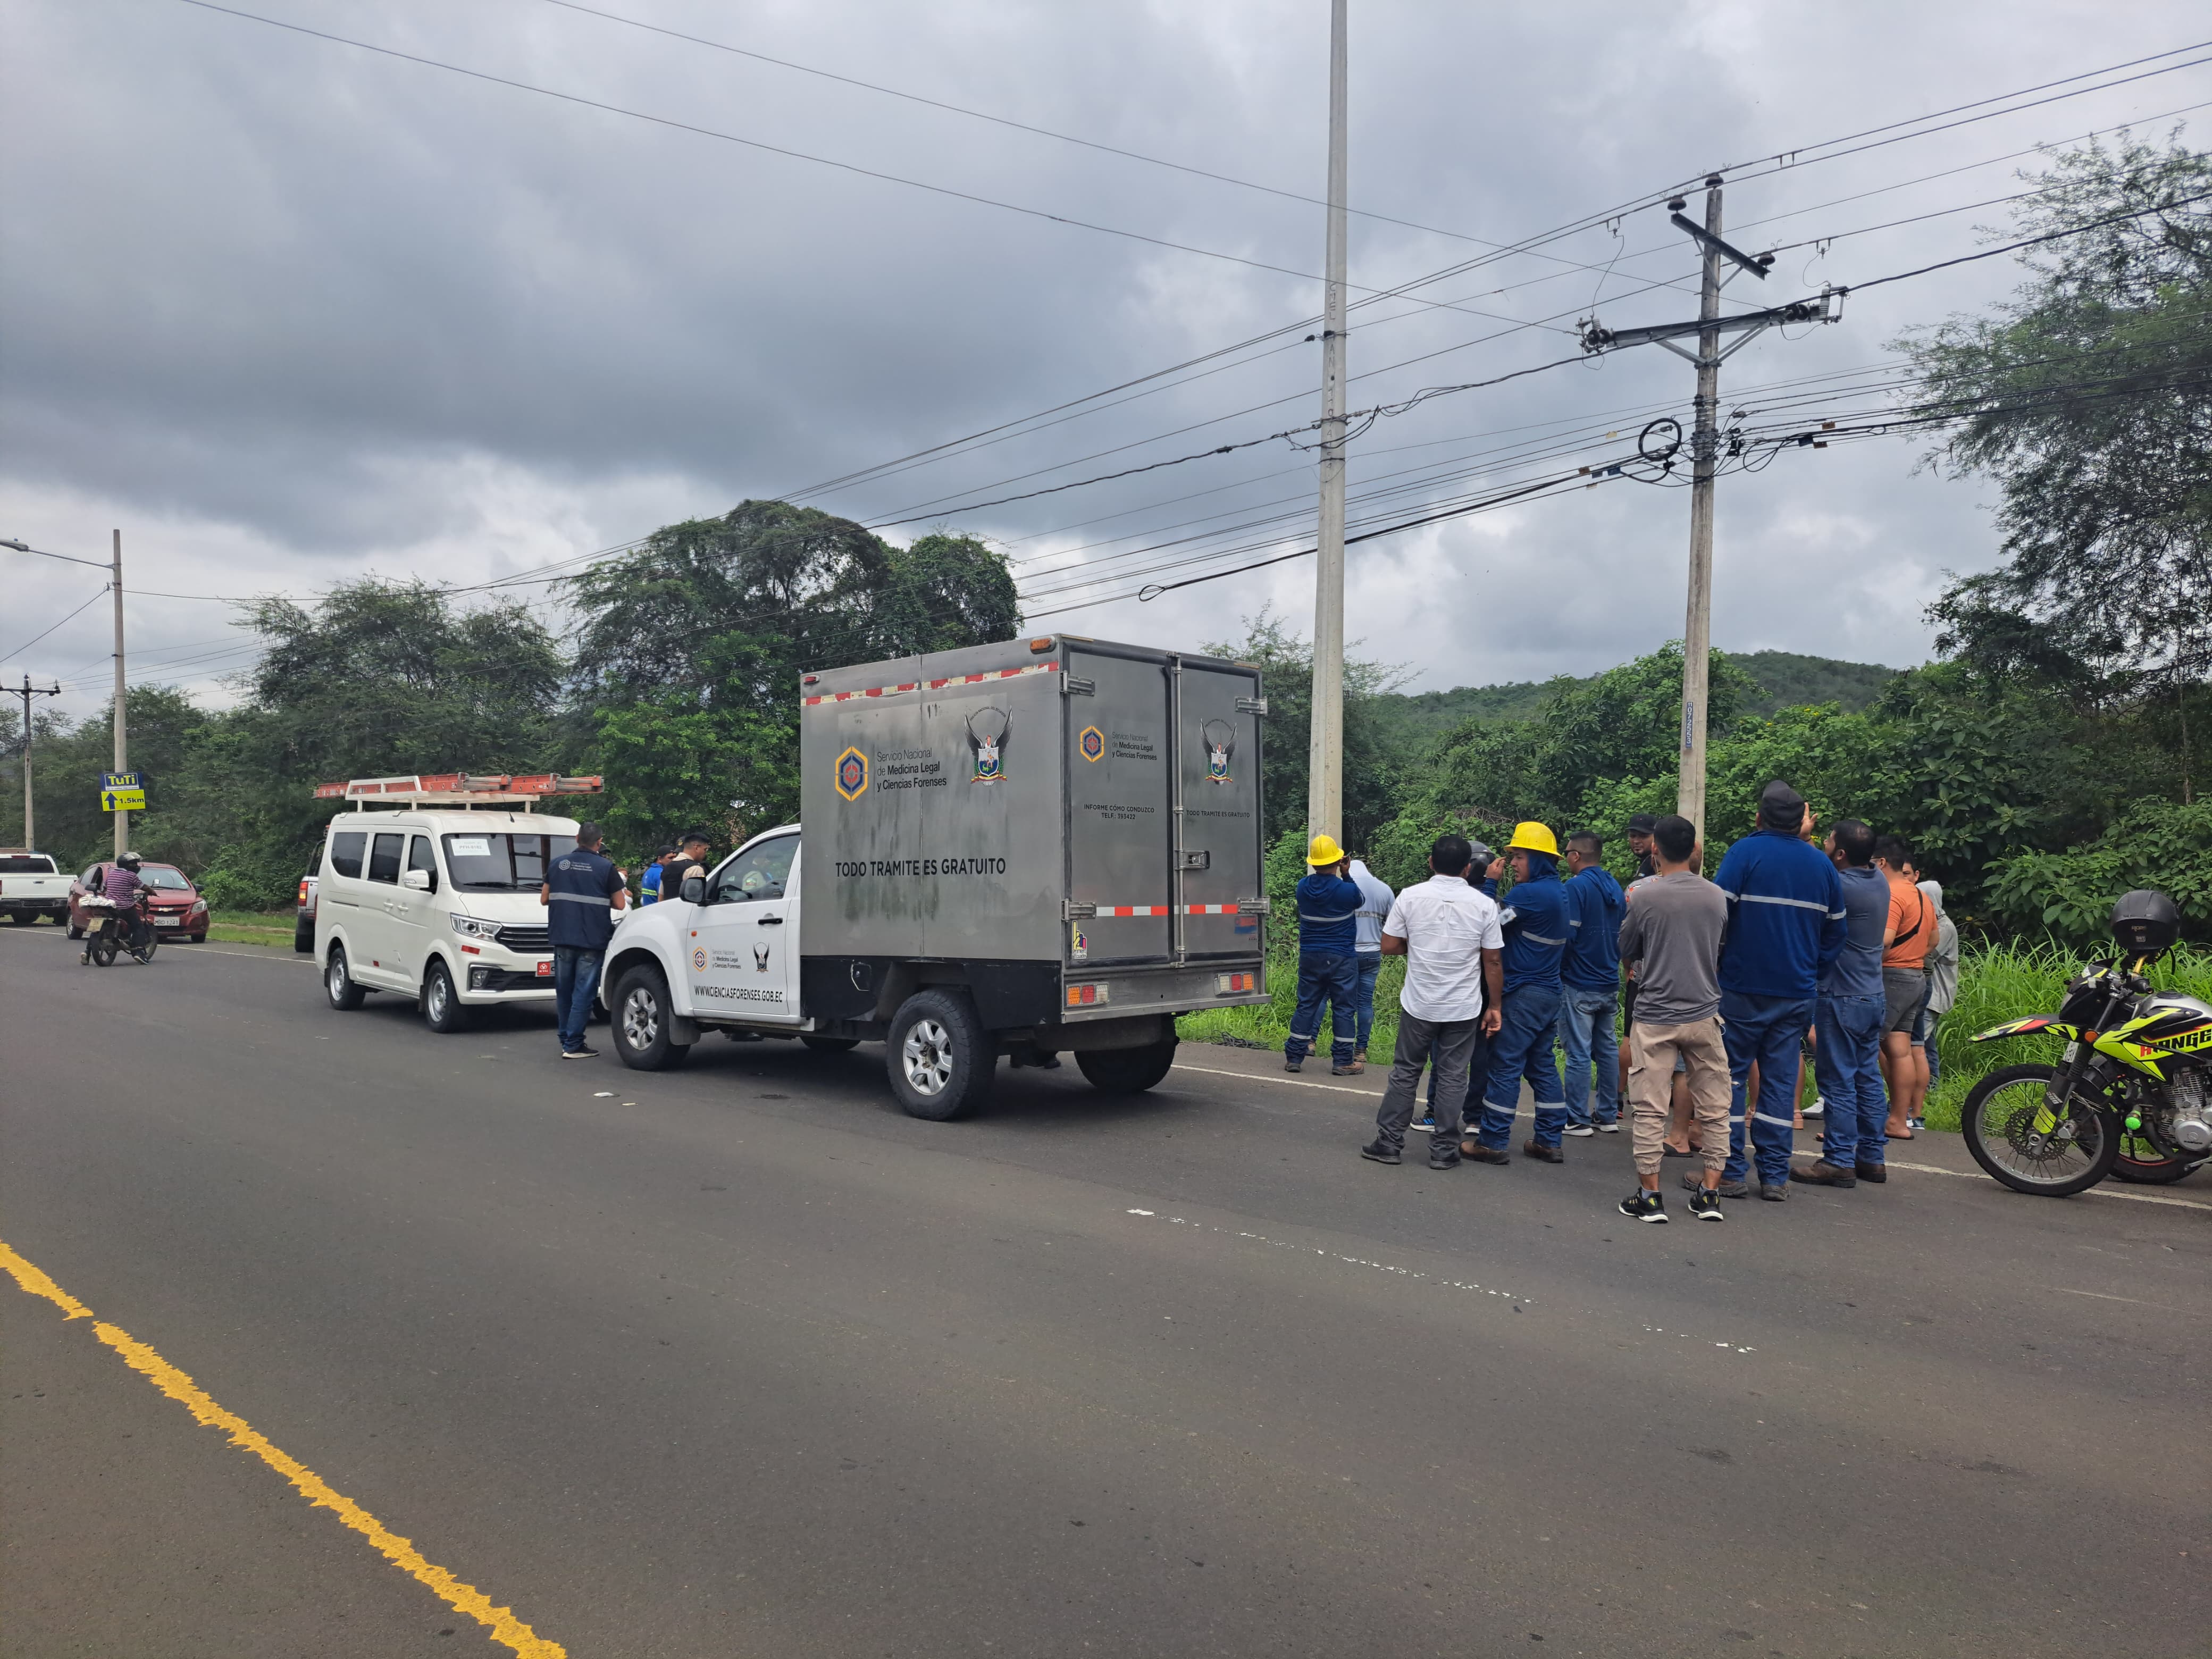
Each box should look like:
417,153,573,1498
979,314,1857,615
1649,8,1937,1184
1621,814,1745,1221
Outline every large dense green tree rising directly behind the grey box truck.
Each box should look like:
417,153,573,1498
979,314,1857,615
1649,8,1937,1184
568,502,1022,849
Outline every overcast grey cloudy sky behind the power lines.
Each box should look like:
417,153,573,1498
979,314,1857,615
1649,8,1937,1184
13,0,2212,721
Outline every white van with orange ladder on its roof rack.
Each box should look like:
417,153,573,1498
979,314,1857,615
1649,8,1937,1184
314,778,597,1033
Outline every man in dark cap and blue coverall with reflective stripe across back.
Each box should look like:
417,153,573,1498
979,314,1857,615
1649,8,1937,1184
1712,781,1847,1203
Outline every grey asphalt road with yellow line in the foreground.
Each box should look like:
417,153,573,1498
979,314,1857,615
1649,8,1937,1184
0,927,2212,1659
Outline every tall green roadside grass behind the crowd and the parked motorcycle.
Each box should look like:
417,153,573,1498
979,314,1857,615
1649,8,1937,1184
1177,944,2212,1135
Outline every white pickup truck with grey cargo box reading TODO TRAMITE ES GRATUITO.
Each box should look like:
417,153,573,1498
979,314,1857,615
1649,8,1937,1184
599,635,1268,1119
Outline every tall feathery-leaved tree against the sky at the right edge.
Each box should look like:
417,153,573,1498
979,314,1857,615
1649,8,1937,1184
1898,137,2212,694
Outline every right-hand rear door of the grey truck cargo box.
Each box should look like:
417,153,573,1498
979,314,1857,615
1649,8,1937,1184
1177,661,1261,960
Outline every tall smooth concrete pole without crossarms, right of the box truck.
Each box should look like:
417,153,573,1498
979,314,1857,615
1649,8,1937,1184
1305,0,1345,836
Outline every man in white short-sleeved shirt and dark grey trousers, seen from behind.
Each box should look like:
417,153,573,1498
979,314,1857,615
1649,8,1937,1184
1360,836,1506,1170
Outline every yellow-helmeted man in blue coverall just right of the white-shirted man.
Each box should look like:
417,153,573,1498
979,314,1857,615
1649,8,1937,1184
1460,823,1571,1163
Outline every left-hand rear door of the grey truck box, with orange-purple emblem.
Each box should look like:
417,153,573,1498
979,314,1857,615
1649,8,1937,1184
1062,639,1175,967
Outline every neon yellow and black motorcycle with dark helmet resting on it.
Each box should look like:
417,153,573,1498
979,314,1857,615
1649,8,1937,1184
1960,889,2212,1199
